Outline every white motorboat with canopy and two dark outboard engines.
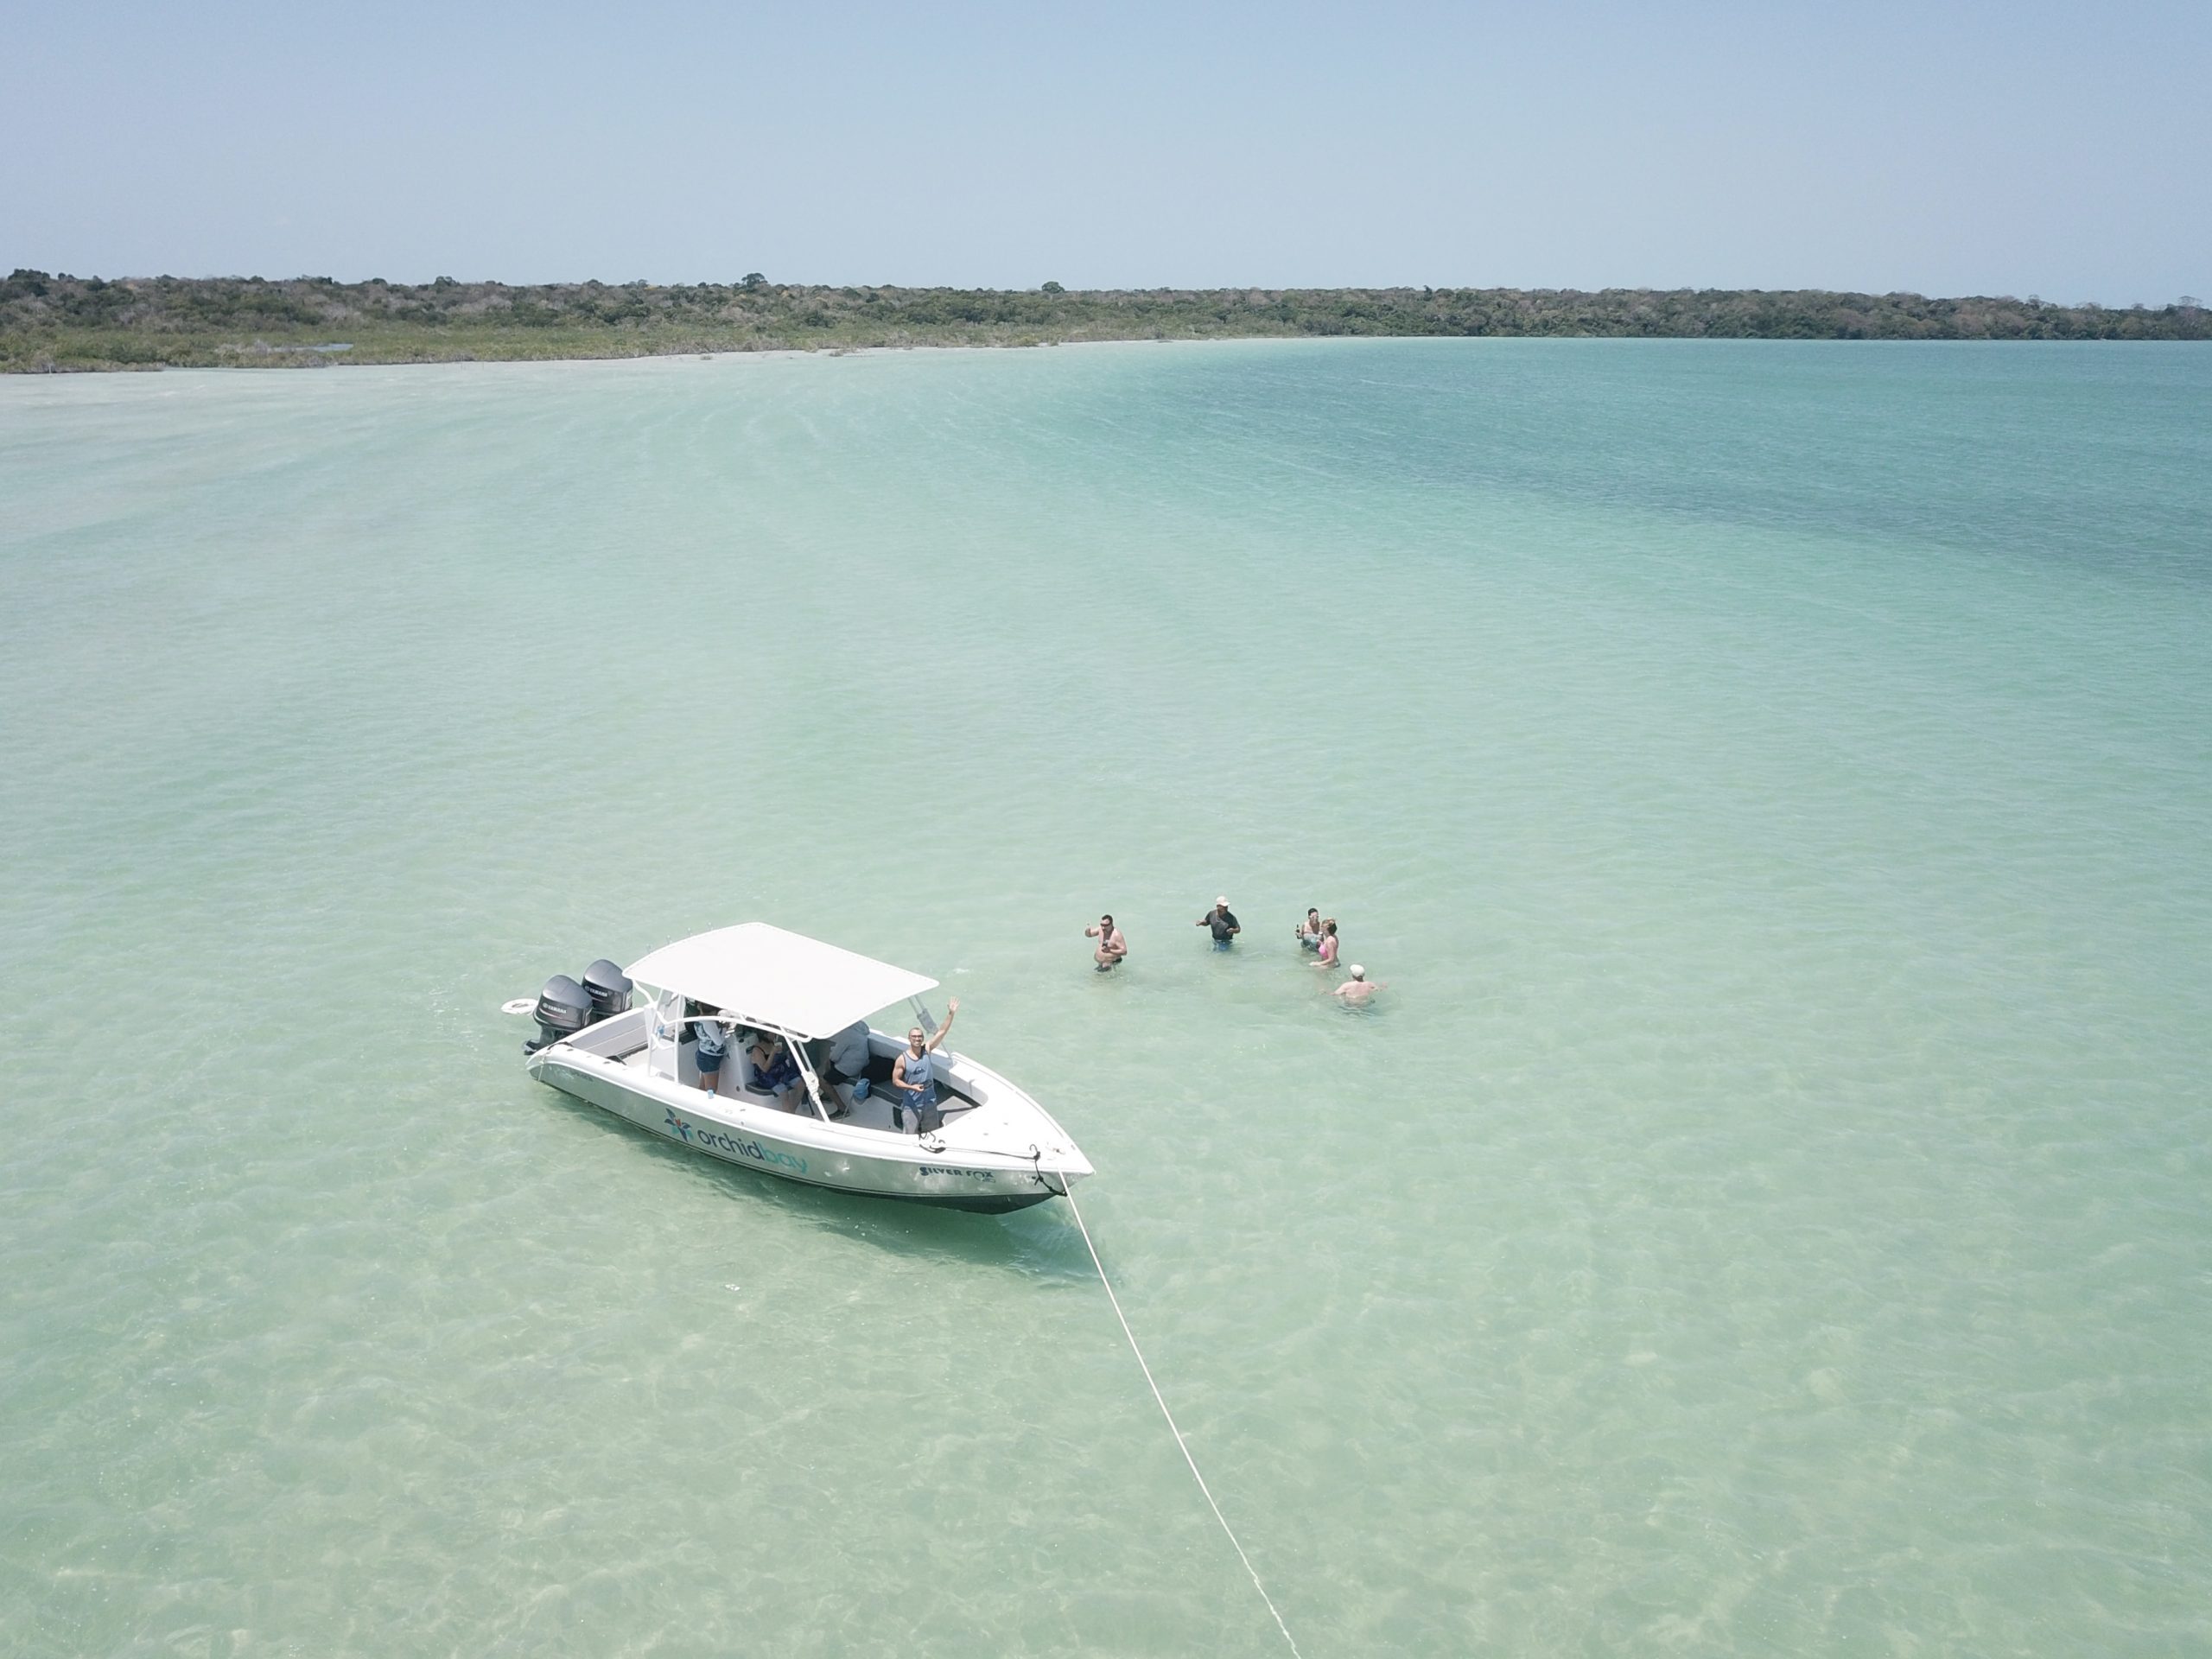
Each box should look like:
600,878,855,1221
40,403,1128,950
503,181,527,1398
511,923,1090,1210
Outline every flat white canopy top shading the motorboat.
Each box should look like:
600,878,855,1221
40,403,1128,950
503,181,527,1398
631,923,938,1038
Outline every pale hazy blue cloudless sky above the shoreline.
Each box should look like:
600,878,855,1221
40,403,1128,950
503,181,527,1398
0,0,2212,305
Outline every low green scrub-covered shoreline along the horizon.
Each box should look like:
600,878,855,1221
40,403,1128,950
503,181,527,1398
0,270,2212,374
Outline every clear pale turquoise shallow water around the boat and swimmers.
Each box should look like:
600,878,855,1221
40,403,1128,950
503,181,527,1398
0,343,2212,1659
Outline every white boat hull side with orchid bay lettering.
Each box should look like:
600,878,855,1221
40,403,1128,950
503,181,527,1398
529,1044,1071,1214
